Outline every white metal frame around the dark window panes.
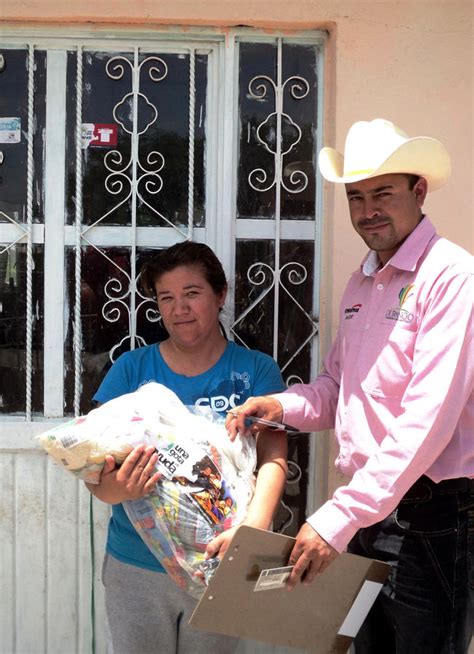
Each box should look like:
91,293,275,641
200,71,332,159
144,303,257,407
0,26,327,524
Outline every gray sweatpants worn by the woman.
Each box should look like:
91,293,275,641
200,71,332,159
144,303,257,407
102,554,238,654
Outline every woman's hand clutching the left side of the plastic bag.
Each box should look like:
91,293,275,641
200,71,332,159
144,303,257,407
86,445,161,504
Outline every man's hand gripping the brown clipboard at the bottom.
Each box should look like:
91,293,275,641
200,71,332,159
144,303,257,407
286,522,339,590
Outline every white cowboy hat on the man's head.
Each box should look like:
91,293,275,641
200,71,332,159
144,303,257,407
319,118,451,191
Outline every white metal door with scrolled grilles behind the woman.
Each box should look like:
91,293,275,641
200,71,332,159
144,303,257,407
0,30,322,654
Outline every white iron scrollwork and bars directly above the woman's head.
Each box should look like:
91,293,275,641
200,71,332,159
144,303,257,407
74,48,195,380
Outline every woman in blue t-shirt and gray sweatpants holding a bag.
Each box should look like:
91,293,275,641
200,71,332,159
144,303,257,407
88,241,286,654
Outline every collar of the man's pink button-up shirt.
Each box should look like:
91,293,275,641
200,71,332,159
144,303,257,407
361,216,436,277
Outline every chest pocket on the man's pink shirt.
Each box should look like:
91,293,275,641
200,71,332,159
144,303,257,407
358,321,418,400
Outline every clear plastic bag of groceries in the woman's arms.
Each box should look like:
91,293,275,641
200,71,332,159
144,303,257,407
38,382,257,597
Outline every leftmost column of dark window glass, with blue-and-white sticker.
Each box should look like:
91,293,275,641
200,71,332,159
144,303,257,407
0,48,46,414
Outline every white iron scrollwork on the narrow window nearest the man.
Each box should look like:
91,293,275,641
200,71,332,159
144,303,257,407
231,39,319,532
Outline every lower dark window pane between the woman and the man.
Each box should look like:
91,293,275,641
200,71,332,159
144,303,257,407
233,239,317,536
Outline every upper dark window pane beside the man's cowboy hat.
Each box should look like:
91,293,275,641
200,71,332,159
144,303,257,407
237,43,317,220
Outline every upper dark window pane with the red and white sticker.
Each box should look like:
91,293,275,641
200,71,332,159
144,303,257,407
66,52,207,227
